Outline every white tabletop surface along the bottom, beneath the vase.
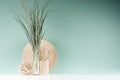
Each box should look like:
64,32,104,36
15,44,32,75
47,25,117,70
0,74,120,80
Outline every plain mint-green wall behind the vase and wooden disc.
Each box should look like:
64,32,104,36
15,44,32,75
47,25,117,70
0,0,120,74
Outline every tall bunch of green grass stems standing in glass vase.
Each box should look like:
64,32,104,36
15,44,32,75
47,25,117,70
12,0,51,74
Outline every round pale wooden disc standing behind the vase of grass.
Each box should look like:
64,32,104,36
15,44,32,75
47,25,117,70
22,40,57,70
